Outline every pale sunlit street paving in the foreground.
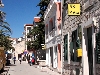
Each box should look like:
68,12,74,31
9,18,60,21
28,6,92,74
7,61,60,75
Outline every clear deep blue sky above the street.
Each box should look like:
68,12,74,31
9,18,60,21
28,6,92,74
0,0,40,38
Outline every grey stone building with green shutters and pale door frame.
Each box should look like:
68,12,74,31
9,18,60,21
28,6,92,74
62,0,100,75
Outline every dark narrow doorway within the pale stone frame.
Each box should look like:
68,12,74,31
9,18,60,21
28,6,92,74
87,27,93,75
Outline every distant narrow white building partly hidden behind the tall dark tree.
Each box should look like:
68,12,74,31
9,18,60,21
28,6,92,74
24,24,33,50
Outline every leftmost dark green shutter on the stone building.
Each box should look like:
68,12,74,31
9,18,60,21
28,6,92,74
64,34,68,61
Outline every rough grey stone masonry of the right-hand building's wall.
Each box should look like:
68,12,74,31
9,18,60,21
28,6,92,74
62,0,100,75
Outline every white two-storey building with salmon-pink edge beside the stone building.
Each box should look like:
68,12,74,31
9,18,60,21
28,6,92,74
44,0,61,72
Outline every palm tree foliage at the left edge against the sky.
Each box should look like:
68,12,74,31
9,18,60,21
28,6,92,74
0,7,14,50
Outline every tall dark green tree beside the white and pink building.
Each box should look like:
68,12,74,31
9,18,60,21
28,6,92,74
28,0,50,49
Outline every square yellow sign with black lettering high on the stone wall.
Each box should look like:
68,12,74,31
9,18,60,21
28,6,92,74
68,4,80,16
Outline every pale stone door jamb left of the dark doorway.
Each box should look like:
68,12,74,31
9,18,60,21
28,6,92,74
82,28,89,75
